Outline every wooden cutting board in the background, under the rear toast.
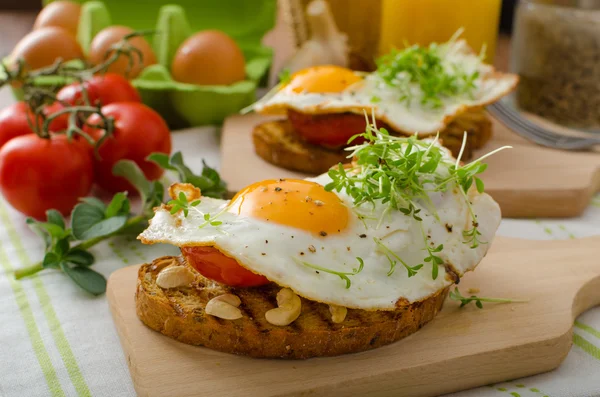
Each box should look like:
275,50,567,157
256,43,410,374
221,114,600,218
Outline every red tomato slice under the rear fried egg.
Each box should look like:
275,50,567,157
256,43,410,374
288,110,387,148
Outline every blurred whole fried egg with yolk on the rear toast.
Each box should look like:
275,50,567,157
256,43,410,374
252,40,518,136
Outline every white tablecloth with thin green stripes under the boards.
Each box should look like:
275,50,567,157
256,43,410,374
0,128,600,397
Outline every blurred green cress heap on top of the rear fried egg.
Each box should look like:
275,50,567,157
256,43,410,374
377,33,479,108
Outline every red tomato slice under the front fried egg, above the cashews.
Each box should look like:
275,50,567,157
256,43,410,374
181,247,269,287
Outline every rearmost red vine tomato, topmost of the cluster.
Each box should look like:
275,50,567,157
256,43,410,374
56,73,142,106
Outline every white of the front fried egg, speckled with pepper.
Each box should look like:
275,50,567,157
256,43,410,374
139,169,500,310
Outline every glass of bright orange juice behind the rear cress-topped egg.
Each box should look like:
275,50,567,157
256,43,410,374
379,0,502,63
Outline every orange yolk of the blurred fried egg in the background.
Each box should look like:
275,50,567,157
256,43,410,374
284,65,362,94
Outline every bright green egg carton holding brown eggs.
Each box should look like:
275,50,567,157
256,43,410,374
10,0,277,128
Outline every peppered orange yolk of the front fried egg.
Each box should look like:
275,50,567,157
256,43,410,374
229,179,348,237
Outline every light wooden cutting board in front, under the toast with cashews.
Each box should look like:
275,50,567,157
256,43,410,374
107,237,600,397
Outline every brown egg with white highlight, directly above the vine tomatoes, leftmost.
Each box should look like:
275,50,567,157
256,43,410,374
10,26,83,70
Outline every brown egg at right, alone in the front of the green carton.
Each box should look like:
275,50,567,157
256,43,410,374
171,30,246,85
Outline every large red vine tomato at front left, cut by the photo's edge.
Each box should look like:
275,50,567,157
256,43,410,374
0,134,94,219
